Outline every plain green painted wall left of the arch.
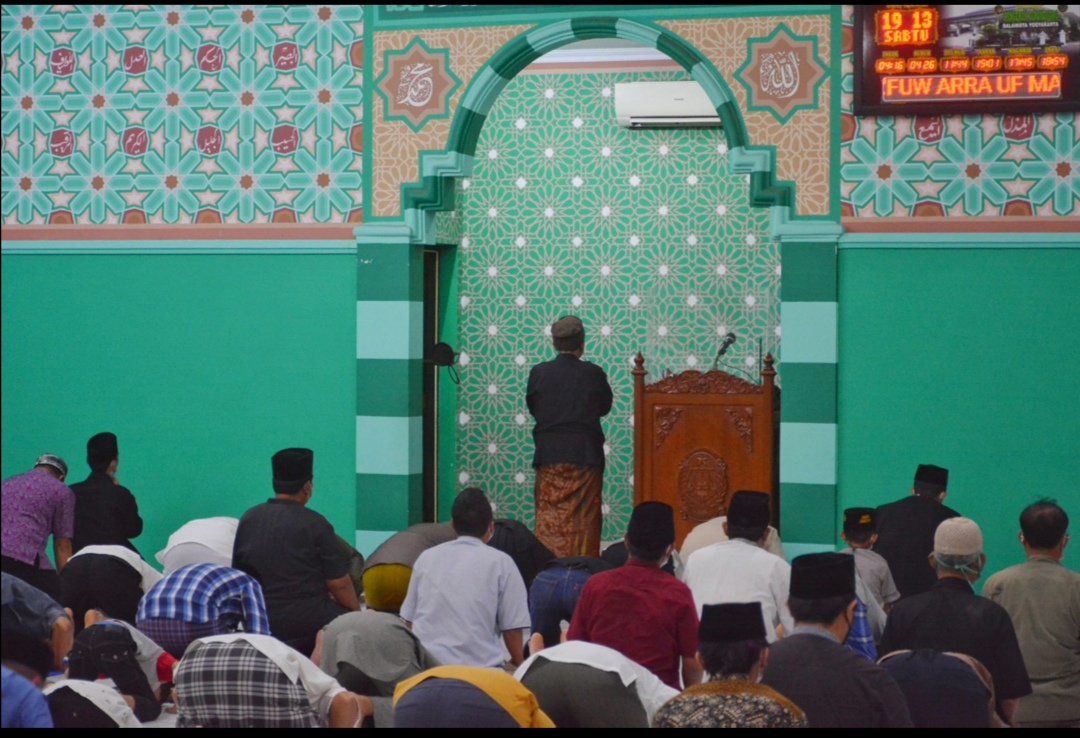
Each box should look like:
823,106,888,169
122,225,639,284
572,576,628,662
0,252,357,561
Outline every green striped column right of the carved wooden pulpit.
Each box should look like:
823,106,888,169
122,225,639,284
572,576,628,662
780,223,841,550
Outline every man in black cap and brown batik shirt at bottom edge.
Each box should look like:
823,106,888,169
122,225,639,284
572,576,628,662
651,602,807,728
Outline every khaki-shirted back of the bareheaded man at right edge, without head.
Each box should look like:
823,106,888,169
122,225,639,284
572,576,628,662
983,556,1080,723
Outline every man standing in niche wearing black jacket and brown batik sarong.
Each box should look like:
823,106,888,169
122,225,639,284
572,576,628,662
525,316,611,556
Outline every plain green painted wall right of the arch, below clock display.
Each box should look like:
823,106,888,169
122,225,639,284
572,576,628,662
837,245,1080,575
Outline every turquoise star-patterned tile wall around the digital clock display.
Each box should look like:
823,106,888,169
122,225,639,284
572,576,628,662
840,5,1080,217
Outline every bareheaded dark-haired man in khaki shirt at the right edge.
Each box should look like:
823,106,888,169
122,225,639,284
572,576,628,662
983,500,1080,727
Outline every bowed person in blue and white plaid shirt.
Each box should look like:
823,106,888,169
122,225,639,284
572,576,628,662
135,564,270,658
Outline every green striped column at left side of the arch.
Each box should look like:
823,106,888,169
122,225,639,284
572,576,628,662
356,223,423,539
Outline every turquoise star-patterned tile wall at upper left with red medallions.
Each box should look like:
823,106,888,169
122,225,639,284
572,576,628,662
0,5,363,224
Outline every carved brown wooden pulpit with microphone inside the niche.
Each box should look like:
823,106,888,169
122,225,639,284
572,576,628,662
633,353,779,548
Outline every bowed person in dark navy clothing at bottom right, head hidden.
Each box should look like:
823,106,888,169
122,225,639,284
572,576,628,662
878,648,1008,728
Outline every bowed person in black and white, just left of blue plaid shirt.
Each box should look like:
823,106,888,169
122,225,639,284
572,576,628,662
60,545,161,634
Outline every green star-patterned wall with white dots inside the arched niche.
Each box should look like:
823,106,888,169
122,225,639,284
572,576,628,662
437,71,780,539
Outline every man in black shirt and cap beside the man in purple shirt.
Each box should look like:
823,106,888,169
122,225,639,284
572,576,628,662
71,433,143,553
